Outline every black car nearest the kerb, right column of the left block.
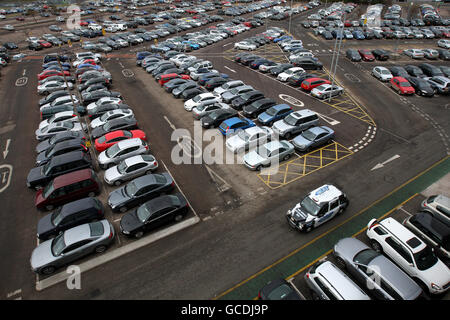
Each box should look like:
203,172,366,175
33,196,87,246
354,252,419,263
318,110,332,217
120,193,189,238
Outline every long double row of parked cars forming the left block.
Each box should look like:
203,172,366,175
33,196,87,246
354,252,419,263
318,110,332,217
27,52,188,275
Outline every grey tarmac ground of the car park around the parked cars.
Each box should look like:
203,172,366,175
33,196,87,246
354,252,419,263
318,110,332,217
0,0,450,299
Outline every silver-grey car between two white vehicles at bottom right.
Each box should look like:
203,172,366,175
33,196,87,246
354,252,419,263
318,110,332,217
334,238,422,300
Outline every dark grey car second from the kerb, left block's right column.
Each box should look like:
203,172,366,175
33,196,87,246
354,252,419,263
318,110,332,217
108,172,175,212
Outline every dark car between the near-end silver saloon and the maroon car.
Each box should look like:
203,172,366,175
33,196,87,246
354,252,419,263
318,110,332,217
37,197,105,241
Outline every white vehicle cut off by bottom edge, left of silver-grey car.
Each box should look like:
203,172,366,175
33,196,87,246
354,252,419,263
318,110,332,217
305,261,370,300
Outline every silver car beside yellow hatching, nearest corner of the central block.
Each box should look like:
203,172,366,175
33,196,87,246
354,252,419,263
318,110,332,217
243,141,294,171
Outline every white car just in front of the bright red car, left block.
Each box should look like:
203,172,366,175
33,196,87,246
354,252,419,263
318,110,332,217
98,138,148,169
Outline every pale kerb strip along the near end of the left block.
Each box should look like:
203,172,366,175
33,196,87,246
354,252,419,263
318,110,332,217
36,216,200,291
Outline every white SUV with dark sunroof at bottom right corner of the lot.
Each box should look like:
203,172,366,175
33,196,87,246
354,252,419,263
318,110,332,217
366,218,450,294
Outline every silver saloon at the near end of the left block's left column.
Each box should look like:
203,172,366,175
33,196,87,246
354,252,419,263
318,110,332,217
30,219,115,275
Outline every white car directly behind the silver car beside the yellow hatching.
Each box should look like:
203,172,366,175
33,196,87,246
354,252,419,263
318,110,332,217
226,126,275,153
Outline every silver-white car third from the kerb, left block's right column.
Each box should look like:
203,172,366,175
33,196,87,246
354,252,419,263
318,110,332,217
105,154,158,186
